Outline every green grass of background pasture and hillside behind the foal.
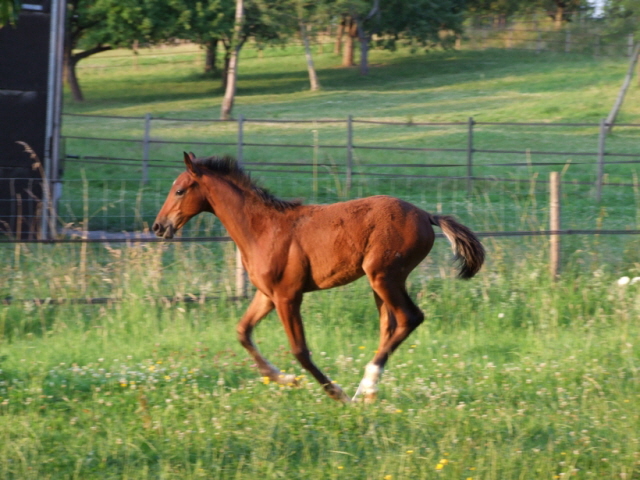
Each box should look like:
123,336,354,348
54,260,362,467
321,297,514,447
56,46,640,234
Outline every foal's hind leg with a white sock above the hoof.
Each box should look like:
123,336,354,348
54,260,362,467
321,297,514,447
354,274,424,402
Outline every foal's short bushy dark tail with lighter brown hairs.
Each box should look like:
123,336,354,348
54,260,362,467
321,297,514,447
431,215,484,279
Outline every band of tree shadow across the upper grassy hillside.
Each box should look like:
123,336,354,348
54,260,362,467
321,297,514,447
65,50,616,113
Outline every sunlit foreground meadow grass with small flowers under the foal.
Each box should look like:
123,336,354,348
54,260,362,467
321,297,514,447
0,241,640,479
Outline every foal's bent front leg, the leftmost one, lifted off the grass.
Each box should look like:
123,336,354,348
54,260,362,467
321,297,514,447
236,290,297,385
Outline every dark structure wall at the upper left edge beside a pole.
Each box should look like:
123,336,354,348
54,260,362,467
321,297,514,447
0,2,51,238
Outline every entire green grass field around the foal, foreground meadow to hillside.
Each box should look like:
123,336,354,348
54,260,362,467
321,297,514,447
0,43,640,480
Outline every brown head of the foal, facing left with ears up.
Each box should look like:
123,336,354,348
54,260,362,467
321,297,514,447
153,152,212,238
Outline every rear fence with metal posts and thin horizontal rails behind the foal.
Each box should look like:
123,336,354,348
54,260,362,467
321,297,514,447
58,114,640,191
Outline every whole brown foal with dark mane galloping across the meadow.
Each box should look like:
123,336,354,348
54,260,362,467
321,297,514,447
153,153,484,402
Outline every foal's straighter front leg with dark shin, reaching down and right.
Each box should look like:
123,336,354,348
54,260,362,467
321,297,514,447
275,294,351,403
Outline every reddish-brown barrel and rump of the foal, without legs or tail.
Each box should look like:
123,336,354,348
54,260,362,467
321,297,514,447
294,195,434,289
